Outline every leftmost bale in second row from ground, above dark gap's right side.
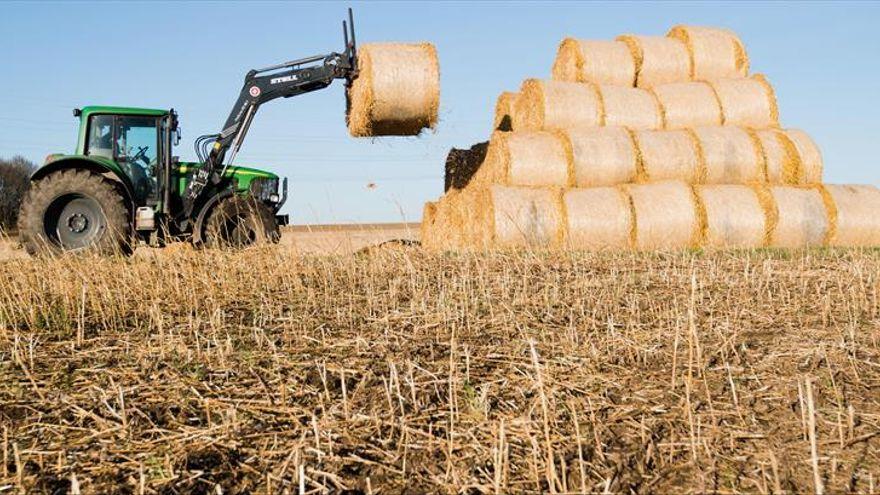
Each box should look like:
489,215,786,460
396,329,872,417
473,131,571,186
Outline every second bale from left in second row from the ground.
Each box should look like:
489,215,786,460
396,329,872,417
562,127,638,187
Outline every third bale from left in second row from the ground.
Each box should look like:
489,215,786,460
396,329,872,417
634,130,703,182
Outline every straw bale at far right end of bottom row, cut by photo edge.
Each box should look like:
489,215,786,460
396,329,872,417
824,184,880,247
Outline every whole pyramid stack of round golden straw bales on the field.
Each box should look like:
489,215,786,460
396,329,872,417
422,26,880,250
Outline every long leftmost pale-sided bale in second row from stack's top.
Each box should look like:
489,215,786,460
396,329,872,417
513,79,603,131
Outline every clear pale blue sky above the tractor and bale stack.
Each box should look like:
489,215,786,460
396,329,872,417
0,1,880,223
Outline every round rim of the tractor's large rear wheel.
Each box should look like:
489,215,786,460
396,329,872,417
43,193,107,251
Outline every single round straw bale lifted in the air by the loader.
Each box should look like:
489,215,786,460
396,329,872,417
347,43,440,137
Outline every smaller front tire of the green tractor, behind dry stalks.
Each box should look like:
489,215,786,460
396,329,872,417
202,196,281,249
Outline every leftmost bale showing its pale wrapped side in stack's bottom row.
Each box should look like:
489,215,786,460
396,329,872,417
478,185,565,248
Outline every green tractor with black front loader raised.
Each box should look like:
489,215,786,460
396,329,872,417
18,9,357,254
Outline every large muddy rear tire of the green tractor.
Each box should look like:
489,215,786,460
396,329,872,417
18,169,133,255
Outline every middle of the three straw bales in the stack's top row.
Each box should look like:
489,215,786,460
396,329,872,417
617,35,691,88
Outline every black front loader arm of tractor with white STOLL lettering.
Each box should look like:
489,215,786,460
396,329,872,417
182,9,357,221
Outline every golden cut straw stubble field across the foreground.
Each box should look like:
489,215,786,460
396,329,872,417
0,240,880,493
